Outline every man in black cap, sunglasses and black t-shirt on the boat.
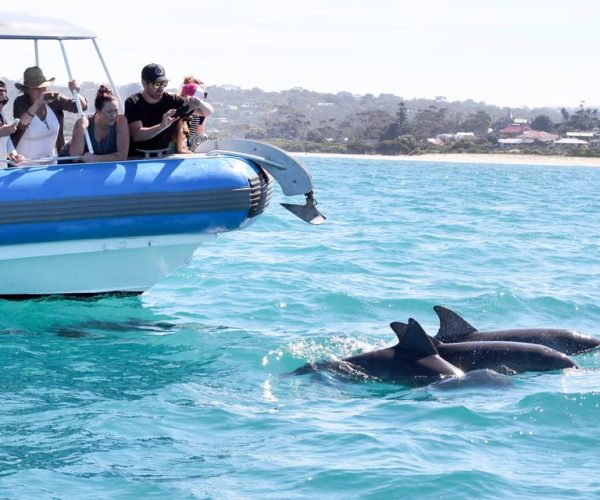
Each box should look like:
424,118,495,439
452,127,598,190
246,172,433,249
125,63,201,156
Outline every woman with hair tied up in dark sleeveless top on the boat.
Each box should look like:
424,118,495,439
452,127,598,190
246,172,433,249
59,85,129,162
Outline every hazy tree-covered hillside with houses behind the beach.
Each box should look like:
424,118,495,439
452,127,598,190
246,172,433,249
209,87,600,156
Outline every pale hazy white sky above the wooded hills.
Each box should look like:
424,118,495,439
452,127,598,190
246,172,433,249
0,0,600,108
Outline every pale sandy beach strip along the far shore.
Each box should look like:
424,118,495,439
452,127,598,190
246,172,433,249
289,152,600,167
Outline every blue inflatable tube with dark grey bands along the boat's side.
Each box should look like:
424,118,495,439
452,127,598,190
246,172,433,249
0,157,260,245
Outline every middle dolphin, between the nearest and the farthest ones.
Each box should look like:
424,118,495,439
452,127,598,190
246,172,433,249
390,321,579,375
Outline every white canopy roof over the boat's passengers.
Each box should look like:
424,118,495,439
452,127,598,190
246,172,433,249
0,12,96,40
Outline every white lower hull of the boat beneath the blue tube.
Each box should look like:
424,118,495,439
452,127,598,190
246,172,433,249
0,234,216,298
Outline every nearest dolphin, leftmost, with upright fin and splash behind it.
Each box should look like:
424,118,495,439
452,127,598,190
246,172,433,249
293,318,464,383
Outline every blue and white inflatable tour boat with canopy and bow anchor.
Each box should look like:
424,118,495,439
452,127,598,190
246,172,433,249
0,13,325,299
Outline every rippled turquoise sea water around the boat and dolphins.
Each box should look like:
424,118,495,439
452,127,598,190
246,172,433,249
0,157,600,499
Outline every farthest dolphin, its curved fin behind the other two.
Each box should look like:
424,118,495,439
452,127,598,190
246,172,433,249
433,306,600,354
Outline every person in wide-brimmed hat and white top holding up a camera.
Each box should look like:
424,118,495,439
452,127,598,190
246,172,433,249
11,66,88,163
